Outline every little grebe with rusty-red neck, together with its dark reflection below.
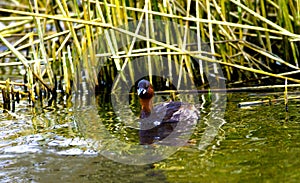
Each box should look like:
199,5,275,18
137,79,199,145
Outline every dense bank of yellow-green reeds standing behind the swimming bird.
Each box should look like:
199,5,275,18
0,0,300,110
